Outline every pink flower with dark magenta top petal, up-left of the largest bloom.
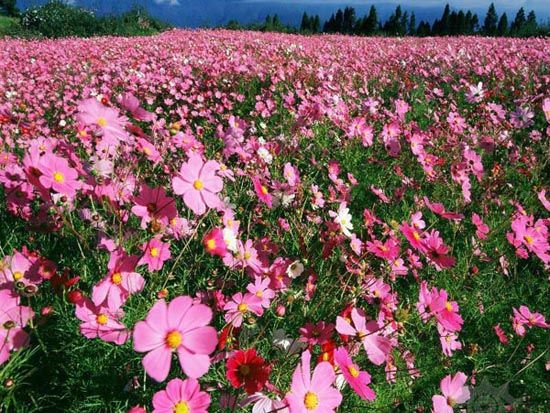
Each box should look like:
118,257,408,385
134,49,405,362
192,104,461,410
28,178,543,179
92,249,145,308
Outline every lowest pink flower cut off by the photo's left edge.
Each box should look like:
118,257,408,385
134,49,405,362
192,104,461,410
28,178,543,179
0,289,33,365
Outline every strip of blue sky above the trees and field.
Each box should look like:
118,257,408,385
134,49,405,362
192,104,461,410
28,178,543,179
18,0,550,27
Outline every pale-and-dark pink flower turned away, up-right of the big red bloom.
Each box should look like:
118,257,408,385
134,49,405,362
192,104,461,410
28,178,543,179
336,308,391,366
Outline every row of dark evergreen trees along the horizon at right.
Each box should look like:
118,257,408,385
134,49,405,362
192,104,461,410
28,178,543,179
226,3,550,37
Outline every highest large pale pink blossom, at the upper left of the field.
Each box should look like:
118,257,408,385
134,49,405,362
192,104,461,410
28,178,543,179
76,98,130,145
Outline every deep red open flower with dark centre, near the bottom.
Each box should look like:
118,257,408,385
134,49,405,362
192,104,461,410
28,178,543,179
226,349,271,394
